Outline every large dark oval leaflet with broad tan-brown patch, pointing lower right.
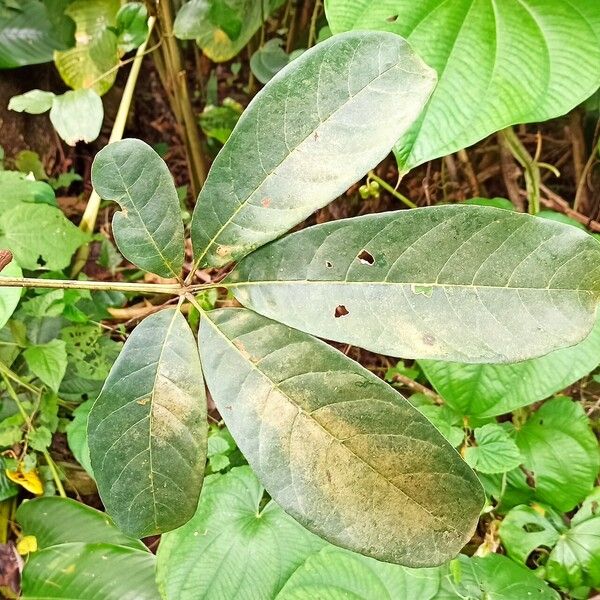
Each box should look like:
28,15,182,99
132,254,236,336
200,309,483,566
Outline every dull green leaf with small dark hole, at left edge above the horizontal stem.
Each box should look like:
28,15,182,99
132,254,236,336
0,203,89,271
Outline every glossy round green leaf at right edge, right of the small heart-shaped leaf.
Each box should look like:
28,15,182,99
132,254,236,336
509,398,600,512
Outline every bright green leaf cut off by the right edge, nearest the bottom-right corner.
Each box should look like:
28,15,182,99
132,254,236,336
546,488,600,589
